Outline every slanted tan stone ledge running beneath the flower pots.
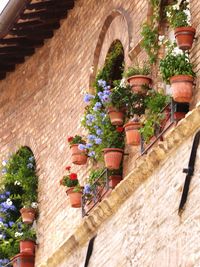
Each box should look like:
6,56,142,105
39,102,200,267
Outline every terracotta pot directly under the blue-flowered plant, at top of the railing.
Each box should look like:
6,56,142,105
103,148,124,170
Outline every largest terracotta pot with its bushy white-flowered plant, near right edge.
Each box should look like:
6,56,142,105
160,46,195,103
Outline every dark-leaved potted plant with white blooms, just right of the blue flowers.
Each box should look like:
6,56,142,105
103,80,132,126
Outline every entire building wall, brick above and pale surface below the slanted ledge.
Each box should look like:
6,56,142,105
0,0,200,267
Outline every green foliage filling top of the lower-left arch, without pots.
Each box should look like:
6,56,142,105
2,147,38,206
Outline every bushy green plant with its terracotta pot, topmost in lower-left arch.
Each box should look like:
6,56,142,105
0,147,38,224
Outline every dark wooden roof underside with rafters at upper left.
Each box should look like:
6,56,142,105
0,0,75,80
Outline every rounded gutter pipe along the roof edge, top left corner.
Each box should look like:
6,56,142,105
0,0,30,38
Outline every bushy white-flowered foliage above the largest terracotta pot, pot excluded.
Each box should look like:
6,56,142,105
160,46,195,83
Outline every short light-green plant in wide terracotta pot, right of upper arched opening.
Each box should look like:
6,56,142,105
124,62,152,94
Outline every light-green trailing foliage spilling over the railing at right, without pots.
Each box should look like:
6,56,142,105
140,90,170,143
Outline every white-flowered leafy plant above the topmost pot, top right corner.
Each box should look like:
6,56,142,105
166,0,191,29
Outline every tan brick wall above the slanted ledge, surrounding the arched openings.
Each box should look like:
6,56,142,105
0,0,200,267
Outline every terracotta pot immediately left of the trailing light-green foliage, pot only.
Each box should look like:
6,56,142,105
124,121,141,146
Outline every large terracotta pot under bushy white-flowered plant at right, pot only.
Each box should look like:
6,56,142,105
170,75,194,103
